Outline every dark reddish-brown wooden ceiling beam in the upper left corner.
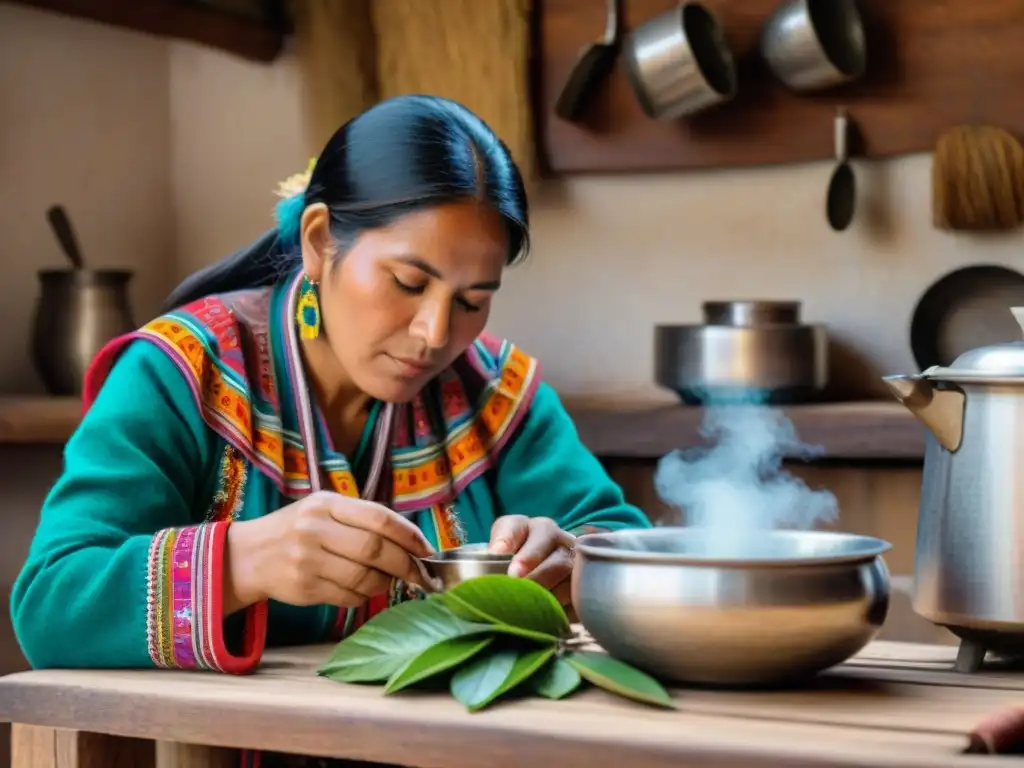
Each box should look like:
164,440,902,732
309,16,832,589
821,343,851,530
7,0,285,62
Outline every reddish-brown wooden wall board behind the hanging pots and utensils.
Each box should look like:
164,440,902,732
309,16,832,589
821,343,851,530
537,0,1024,173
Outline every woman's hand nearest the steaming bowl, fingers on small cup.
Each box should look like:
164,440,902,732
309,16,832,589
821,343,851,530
490,515,575,605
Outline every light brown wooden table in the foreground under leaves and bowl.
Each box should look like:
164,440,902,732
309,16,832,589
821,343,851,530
0,642,1024,768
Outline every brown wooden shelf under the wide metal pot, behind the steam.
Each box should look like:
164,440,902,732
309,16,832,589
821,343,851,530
564,397,925,461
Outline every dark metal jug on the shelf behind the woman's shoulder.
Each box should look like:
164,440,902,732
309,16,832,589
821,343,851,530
32,269,135,395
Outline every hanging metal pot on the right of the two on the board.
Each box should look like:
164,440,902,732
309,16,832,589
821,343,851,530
761,0,867,91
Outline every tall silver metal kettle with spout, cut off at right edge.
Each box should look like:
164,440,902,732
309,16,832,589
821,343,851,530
885,307,1024,671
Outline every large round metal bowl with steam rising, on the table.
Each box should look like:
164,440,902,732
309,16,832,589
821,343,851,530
572,527,891,686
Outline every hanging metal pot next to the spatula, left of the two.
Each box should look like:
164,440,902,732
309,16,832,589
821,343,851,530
624,2,736,120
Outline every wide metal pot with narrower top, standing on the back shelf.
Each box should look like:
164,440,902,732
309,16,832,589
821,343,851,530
654,301,828,404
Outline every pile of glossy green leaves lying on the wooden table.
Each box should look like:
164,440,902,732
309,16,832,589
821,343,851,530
318,575,674,712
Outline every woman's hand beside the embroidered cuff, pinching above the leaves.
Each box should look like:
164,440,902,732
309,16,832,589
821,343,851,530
223,492,434,615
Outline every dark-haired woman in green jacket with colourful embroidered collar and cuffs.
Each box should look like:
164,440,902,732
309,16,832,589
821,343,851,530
11,96,648,768
